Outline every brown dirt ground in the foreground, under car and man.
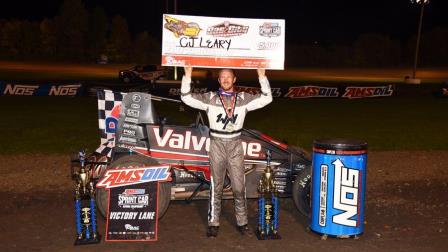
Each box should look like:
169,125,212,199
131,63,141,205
0,151,448,251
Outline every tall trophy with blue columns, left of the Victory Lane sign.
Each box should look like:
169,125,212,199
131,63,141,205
71,150,101,245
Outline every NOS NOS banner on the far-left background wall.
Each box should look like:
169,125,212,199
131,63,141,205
0,82,84,96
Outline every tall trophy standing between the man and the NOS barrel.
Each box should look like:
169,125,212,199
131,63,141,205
257,150,280,240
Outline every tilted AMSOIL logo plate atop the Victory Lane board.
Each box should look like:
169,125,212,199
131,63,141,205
97,166,170,189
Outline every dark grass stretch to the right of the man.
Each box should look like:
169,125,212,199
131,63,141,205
246,97,448,150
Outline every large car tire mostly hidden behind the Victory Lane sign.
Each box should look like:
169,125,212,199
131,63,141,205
95,155,171,219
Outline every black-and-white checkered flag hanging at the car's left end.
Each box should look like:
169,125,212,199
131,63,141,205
95,90,126,157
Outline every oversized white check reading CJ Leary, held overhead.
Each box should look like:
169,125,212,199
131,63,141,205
162,14,285,70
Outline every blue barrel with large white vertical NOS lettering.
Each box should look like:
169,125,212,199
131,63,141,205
310,139,367,236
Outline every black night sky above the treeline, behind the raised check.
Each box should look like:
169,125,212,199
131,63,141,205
0,0,448,43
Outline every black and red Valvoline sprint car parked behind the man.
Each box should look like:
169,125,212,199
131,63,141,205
94,93,311,218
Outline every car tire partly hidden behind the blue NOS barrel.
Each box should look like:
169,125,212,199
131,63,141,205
292,162,311,217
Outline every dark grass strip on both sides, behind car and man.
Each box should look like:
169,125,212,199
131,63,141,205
0,97,448,154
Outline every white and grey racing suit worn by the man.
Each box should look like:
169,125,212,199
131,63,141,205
181,76,272,226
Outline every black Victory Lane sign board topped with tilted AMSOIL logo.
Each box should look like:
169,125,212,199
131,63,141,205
97,165,170,241
